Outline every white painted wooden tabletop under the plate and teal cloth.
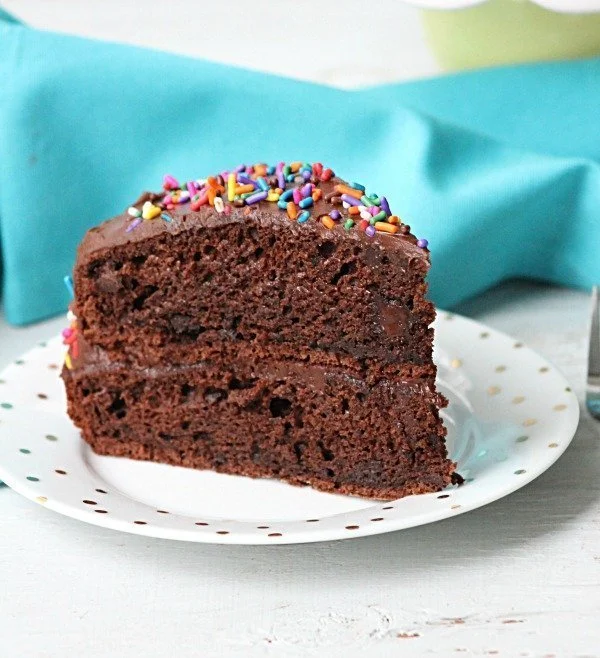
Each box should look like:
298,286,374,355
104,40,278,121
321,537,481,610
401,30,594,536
0,0,600,658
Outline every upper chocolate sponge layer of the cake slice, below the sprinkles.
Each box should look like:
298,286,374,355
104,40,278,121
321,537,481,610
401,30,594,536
75,177,434,366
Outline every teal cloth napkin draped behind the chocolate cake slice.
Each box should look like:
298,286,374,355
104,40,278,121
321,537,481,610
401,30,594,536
0,14,600,324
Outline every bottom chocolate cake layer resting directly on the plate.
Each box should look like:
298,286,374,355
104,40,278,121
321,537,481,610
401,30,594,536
64,348,455,499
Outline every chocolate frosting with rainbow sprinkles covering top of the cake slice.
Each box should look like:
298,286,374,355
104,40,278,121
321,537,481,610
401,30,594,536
78,162,429,267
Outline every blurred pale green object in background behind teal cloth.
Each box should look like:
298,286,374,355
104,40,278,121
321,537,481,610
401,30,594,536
422,0,600,71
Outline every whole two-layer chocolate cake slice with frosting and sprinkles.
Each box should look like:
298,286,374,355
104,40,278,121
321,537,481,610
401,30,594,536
63,162,456,499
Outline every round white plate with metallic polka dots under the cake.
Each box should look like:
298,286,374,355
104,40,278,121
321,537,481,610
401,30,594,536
0,313,579,544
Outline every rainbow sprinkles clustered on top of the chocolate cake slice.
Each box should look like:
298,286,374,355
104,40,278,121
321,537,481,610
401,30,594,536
125,161,428,249
